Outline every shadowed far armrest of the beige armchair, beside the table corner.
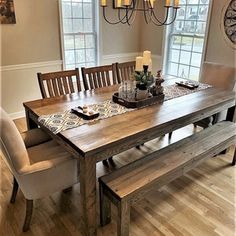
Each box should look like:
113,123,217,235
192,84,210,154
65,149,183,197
21,128,51,148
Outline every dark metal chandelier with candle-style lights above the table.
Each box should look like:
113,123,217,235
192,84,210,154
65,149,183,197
101,0,179,26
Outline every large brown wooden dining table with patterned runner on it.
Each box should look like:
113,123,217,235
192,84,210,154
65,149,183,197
23,79,235,236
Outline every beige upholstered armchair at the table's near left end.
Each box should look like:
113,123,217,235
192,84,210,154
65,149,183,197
0,107,78,231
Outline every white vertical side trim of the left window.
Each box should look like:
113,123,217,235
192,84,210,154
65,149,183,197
58,0,102,70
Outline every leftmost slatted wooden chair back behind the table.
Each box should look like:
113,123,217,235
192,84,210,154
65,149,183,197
37,68,81,98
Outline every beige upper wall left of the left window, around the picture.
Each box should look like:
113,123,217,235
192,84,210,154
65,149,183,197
0,0,61,66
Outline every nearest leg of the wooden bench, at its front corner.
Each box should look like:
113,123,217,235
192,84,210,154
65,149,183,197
117,201,130,236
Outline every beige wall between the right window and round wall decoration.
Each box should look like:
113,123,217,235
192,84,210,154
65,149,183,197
205,0,236,67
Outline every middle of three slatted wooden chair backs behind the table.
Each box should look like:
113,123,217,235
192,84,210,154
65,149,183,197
81,64,118,90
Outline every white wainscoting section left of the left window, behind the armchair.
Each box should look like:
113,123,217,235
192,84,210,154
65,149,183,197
0,60,62,119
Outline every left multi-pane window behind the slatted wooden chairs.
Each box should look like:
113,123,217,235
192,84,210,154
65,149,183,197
60,0,98,70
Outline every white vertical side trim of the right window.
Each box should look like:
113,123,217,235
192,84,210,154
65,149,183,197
162,0,213,79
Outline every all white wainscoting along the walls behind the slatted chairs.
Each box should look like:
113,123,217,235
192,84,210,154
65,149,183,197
0,52,161,119
